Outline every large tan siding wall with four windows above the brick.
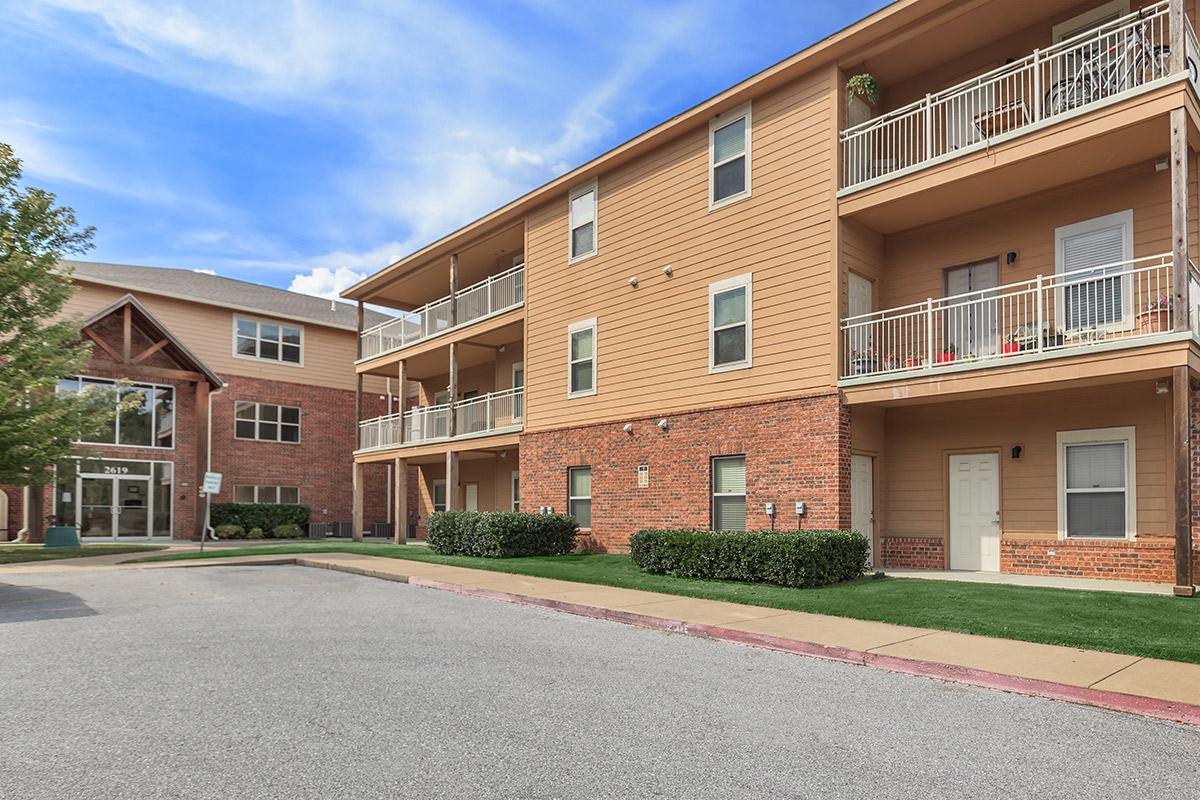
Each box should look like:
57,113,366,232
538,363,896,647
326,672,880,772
526,71,834,429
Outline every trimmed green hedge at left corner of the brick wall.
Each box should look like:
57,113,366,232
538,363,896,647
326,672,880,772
428,511,580,558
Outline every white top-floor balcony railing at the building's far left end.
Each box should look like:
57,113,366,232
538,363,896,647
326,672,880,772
362,264,524,359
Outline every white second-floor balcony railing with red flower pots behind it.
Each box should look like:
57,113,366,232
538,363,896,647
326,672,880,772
840,254,1200,379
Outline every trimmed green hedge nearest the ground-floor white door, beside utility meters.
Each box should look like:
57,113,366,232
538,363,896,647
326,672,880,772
629,530,870,587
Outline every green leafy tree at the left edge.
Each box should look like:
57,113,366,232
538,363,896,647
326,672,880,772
0,143,123,533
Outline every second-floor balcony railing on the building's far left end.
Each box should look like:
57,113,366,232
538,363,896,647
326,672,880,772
359,387,524,451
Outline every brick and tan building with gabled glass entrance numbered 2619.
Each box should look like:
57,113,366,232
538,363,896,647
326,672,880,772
0,261,395,541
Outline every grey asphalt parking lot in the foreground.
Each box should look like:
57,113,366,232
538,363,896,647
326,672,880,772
0,566,1200,800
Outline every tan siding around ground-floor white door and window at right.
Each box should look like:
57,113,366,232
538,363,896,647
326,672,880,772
878,381,1174,537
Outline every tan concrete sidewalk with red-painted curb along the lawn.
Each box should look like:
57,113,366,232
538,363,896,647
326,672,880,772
9,548,1200,724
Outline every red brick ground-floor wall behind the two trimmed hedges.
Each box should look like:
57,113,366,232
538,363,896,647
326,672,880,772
520,395,850,551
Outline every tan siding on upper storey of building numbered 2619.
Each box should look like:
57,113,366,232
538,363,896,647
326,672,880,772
64,283,367,391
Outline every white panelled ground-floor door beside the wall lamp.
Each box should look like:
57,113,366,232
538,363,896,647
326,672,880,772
950,453,1000,572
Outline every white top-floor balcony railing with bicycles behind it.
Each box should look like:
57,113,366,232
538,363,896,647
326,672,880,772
840,0,1176,190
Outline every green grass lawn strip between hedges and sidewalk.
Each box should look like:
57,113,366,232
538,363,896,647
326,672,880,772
137,542,1200,663
